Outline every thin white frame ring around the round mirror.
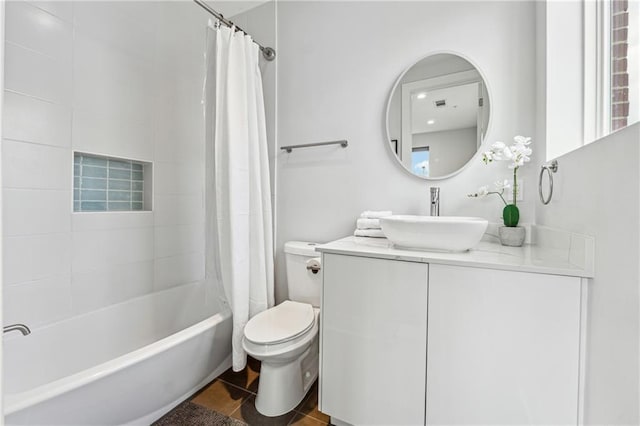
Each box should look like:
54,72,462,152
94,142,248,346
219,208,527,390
384,50,494,181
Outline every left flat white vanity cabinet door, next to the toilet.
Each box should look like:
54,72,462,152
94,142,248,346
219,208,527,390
320,254,428,425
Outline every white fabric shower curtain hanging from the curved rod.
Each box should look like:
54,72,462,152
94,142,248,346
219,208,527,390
207,26,274,371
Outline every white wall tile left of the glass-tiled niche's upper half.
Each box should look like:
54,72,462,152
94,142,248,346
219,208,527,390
2,139,73,190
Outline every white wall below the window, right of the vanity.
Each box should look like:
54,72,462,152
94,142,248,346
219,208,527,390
536,124,640,425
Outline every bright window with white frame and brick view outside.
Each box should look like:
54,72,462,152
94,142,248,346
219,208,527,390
537,0,640,160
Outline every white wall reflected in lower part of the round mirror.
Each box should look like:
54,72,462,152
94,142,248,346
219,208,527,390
413,127,478,176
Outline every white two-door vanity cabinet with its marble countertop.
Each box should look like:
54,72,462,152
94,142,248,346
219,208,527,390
318,235,593,425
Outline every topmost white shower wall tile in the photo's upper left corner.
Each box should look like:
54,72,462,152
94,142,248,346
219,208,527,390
5,1,73,64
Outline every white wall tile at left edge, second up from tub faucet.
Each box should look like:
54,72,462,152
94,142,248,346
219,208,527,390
4,233,71,284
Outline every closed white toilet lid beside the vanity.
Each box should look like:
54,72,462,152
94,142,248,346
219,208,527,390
244,300,315,344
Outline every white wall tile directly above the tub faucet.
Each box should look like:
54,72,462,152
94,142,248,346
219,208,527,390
3,275,72,329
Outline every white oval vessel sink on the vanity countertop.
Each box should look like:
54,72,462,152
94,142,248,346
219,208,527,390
380,215,488,251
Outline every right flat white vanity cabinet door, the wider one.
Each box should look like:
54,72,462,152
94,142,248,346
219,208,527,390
427,265,580,425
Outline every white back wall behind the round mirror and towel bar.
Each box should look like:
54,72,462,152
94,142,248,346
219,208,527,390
276,1,536,300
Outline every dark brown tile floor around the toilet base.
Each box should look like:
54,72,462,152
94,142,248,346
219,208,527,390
154,358,330,426
